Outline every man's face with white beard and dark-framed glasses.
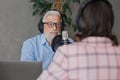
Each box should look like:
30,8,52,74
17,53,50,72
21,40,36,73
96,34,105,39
44,15,62,43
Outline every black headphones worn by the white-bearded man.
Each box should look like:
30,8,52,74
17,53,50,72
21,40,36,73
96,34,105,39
38,9,64,33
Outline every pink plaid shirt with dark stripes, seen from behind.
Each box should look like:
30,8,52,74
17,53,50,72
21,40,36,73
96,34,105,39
37,37,120,80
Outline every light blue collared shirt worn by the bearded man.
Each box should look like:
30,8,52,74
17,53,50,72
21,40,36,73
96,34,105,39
21,34,54,69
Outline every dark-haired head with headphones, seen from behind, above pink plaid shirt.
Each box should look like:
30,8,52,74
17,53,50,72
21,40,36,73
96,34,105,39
77,0,118,45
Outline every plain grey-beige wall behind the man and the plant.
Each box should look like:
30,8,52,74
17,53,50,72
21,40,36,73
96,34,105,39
0,0,120,60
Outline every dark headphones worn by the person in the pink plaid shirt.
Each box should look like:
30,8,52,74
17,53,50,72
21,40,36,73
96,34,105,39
76,0,112,32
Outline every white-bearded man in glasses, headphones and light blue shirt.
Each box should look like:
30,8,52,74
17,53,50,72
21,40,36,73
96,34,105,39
21,10,64,69
